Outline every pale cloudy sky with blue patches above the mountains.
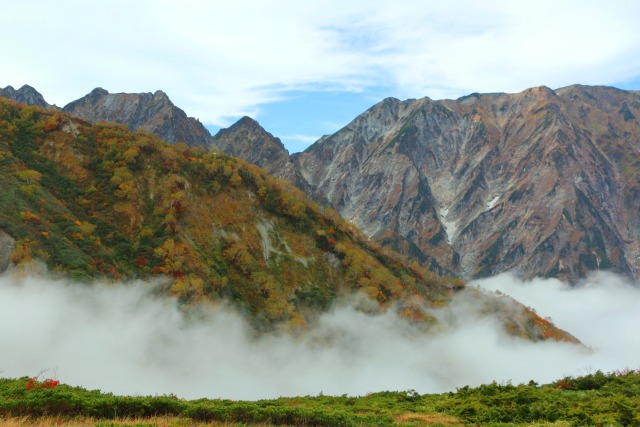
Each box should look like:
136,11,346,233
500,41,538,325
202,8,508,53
0,0,640,152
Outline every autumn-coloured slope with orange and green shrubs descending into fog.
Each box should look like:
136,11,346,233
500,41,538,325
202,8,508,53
0,100,576,342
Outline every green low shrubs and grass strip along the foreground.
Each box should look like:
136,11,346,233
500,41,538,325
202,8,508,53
0,371,640,426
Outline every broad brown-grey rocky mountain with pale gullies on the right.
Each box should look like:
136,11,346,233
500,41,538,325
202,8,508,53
295,86,640,280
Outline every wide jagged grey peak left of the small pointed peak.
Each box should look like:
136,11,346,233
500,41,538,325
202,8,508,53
63,88,212,149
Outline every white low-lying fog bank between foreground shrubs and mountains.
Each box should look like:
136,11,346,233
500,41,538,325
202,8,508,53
0,273,640,399
